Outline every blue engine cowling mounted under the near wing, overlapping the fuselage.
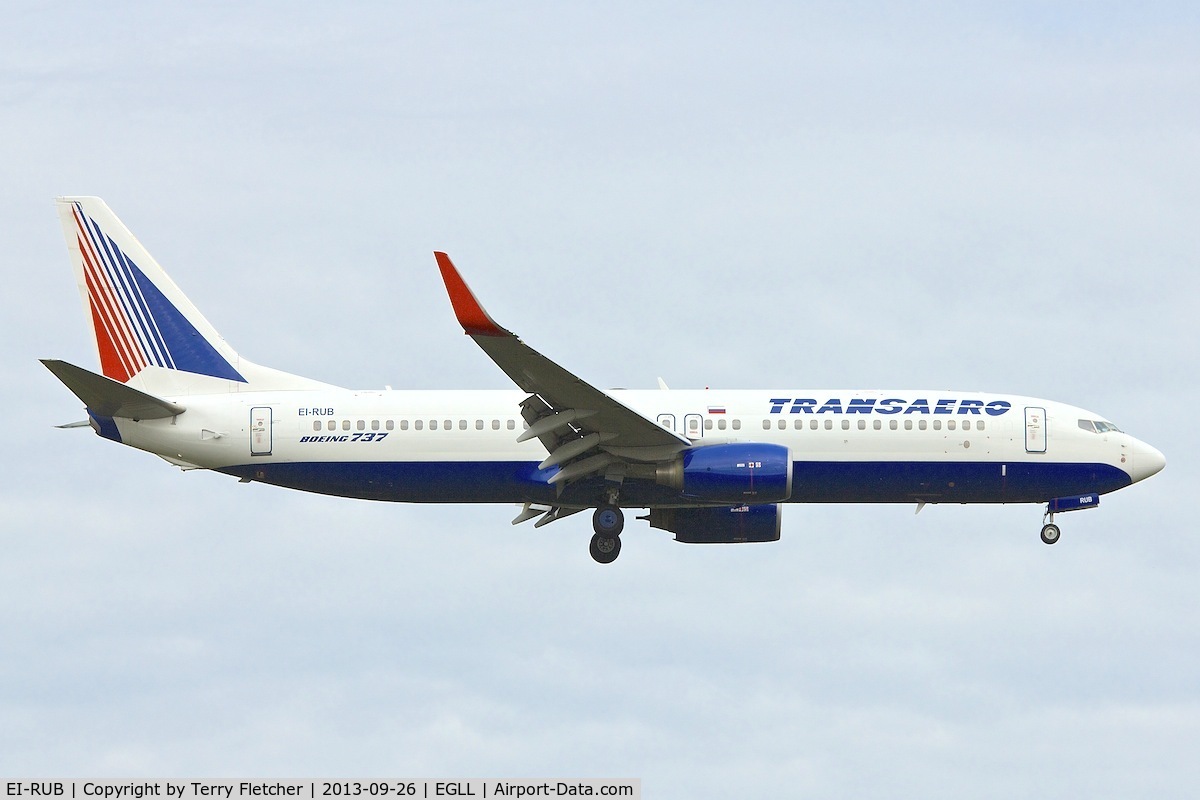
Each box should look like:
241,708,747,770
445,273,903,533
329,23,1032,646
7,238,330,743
682,443,792,503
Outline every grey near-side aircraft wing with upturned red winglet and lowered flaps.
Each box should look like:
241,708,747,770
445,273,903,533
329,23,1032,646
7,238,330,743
434,253,691,482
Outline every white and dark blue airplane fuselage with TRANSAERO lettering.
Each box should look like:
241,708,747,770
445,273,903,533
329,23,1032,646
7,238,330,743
105,389,1162,505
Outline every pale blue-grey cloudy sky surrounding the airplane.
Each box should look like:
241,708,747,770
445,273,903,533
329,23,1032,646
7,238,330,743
0,0,1200,799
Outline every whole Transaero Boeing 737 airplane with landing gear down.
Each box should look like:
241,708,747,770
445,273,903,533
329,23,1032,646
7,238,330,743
42,197,1166,564
